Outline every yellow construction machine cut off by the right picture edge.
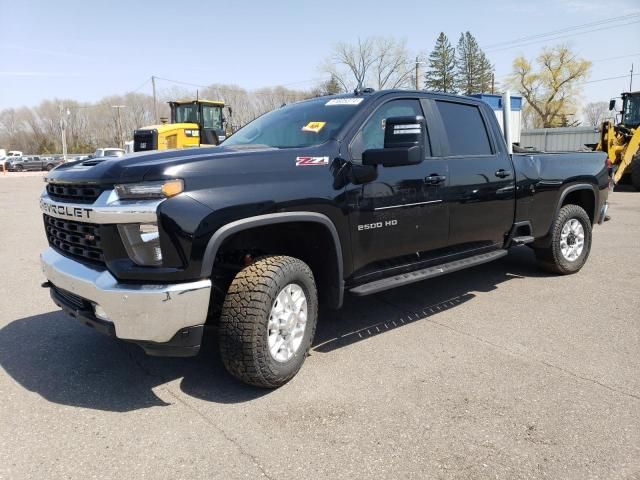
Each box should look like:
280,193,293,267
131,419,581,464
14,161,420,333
596,91,640,191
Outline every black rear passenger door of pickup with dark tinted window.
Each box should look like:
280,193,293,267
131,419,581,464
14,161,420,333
435,99,515,249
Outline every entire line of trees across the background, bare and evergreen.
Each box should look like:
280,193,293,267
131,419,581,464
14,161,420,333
0,31,596,154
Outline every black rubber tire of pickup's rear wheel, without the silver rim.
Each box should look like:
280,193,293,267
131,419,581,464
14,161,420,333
534,205,592,275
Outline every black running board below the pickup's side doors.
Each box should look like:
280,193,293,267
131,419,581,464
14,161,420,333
349,250,507,296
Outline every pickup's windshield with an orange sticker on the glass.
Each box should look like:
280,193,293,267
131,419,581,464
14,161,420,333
223,97,364,148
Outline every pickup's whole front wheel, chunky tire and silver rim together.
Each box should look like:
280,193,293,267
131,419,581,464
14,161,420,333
220,256,318,388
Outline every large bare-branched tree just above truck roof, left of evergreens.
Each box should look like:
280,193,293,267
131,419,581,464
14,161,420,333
322,37,413,91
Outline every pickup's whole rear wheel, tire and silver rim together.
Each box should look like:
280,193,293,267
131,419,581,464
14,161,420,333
535,205,591,275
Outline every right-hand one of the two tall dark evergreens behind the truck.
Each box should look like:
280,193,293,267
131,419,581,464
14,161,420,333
456,32,494,95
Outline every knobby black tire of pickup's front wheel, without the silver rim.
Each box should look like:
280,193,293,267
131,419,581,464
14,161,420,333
219,256,318,388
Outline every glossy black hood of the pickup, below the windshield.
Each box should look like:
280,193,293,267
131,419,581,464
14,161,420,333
47,145,282,185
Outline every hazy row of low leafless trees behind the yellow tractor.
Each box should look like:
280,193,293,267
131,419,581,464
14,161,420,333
0,80,317,153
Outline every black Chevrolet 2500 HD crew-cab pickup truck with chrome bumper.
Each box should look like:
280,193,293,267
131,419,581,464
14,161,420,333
41,90,609,387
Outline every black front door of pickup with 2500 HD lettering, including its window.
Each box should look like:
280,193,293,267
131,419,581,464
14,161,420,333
346,98,448,270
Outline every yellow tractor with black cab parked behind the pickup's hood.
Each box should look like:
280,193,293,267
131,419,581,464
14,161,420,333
133,99,231,152
